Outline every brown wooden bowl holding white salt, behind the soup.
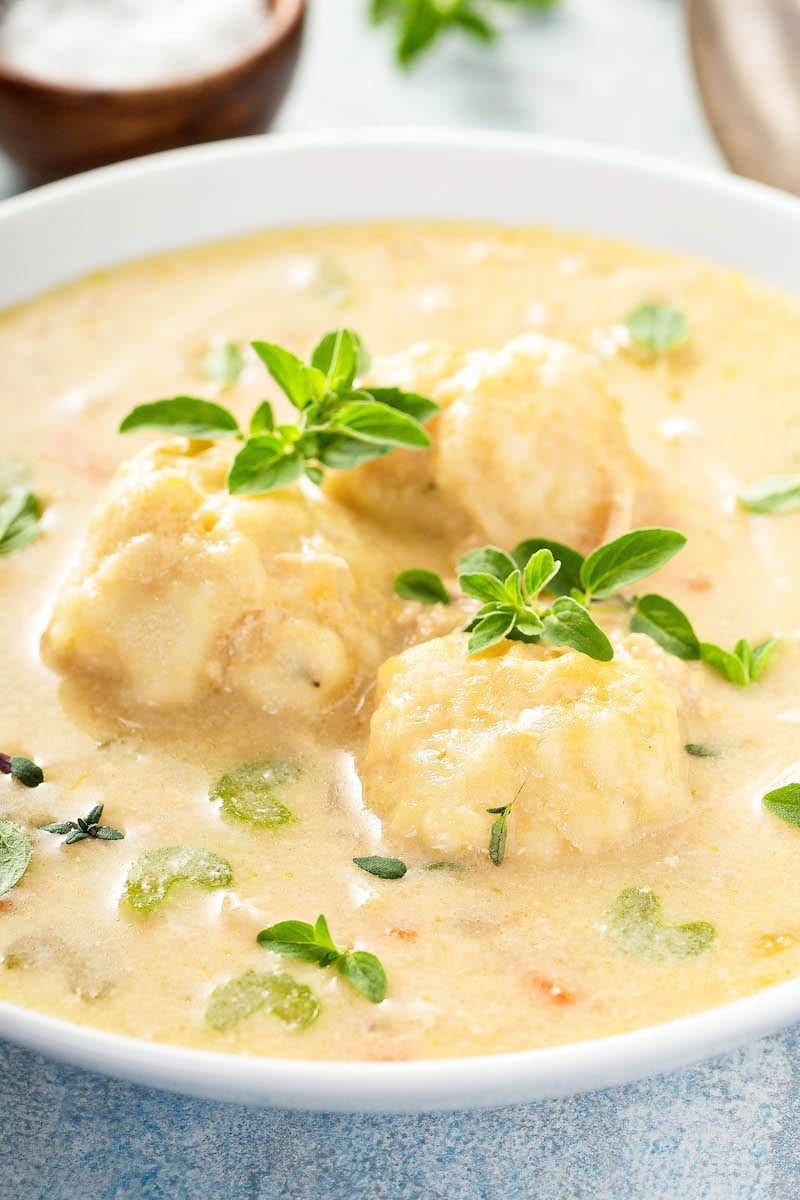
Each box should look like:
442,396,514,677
0,0,306,182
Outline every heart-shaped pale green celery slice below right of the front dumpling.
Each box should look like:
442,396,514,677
608,888,716,962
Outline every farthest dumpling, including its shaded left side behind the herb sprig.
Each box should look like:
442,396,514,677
331,334,637,551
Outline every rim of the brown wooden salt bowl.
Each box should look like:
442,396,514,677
0,0,308,98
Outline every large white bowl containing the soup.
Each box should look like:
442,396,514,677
0,131,800,1111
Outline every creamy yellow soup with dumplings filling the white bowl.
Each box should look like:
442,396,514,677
0,224,800,1060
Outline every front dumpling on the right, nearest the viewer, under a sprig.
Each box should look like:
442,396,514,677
363,634,692,860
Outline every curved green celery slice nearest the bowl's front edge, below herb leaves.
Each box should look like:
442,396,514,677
205,971,320,1033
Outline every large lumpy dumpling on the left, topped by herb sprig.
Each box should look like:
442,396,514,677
43,440,391,714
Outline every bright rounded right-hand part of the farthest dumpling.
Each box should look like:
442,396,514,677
434,334,636,552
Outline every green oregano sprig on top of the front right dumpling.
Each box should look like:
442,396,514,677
395,528,686,662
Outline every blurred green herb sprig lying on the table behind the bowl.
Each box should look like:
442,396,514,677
369,0,559,67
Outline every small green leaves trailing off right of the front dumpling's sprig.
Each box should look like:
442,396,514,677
631,594,780,688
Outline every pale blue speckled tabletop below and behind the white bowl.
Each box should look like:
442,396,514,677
0,0,786,1200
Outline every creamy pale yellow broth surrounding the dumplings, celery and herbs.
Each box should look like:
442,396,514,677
0,224,800,1060
